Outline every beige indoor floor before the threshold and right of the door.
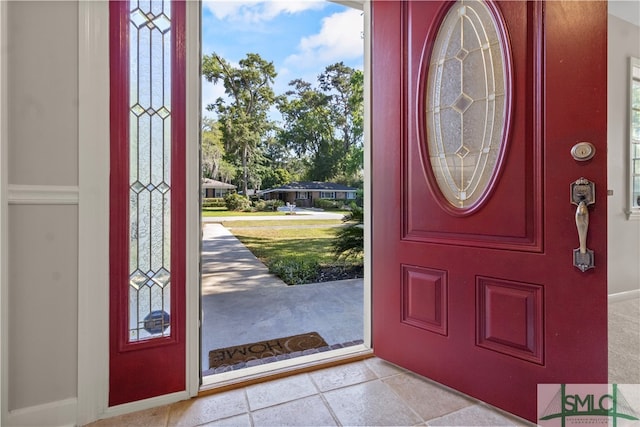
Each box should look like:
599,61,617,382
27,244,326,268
90,299,640,427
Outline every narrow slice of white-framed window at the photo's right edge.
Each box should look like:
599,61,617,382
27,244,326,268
629,58,640,219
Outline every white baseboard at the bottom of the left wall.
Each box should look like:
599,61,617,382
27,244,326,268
7,397,78,427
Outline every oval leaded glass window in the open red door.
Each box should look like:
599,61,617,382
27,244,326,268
425,0,510,210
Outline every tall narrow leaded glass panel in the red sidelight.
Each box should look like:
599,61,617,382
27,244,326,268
129,0,171,342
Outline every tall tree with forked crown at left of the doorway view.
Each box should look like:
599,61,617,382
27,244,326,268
202,53,277,195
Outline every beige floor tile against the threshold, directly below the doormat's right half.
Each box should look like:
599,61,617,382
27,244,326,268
246,374,318,411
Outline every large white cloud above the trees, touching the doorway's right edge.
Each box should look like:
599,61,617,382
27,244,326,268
285,9,364,67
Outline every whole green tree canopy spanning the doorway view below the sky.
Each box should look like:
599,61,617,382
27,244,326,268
202,53,364,195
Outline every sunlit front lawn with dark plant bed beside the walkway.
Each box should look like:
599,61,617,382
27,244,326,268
225,220,363,285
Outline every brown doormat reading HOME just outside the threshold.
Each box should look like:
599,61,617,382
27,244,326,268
209,332,328,369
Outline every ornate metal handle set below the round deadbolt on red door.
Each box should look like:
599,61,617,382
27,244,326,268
571,178,596,273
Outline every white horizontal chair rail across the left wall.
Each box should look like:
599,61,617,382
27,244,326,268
8,184,80,205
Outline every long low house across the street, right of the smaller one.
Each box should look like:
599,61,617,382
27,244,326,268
261,181,356,207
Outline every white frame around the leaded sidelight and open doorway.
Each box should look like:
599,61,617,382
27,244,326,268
75,0,371,425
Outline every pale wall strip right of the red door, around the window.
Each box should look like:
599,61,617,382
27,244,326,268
608,11,640,295
